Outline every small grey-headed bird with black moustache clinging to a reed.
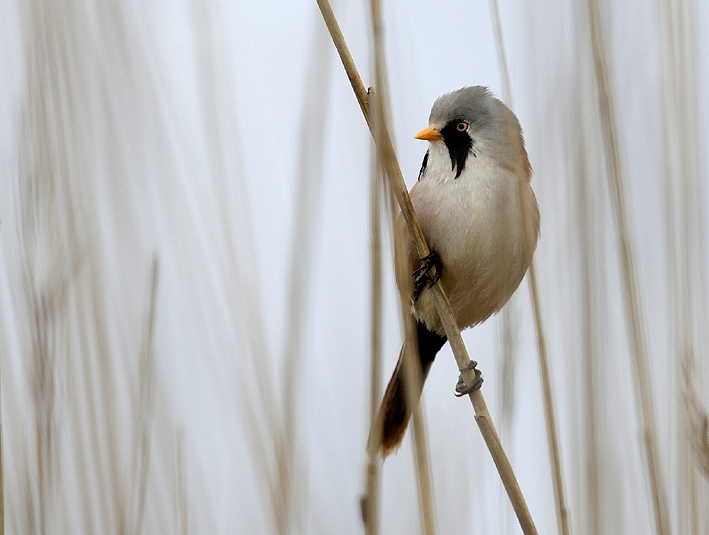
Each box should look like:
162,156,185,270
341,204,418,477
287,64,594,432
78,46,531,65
368,86,539,458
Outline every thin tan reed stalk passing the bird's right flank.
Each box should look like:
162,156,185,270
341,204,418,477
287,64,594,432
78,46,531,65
490,0,569,535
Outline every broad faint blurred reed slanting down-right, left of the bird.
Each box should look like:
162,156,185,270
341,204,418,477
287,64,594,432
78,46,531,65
191,0,290,531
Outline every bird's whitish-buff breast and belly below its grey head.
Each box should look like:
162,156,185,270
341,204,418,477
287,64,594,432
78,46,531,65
399,142,539,334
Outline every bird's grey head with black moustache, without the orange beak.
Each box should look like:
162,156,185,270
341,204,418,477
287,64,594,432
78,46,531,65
429,85,531,178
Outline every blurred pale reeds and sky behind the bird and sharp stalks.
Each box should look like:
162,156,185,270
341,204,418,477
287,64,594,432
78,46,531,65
0,0,709,534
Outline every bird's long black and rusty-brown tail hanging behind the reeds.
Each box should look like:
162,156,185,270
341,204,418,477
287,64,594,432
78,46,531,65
370,322,446,457
